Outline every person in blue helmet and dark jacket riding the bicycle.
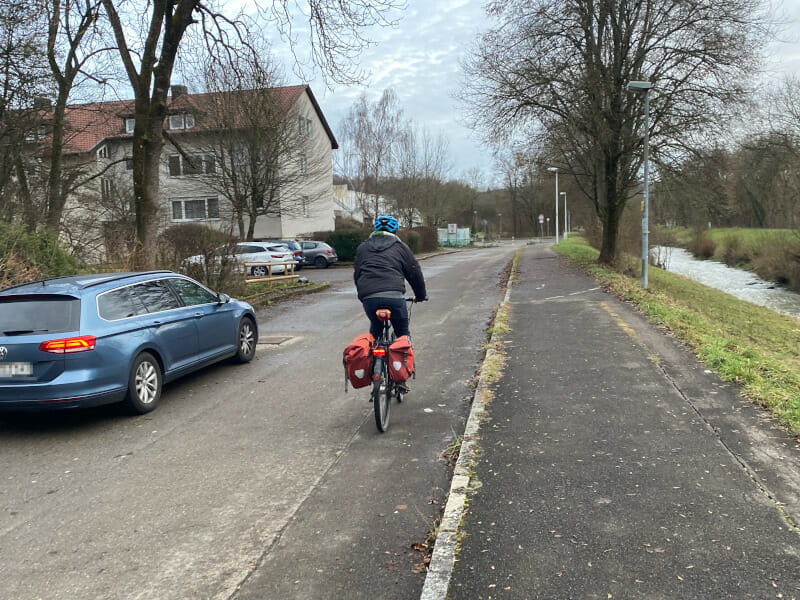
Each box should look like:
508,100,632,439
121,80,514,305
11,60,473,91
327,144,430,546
353,215,428,339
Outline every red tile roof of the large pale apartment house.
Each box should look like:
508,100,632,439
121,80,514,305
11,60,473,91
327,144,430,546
64,85,339,154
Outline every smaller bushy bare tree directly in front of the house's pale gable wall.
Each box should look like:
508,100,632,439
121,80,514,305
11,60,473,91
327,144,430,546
202,53,330,240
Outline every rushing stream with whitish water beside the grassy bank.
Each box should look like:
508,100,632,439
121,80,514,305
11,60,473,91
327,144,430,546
650,246,800,318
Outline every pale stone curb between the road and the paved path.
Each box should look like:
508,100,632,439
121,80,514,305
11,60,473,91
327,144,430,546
420,255,514,600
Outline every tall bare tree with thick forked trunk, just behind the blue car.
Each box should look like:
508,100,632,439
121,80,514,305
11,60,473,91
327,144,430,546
101,0,398,266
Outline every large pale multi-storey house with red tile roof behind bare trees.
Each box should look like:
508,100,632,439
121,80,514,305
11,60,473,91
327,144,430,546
55,85,338,254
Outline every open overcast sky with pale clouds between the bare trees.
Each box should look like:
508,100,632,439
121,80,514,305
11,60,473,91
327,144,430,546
282,0,800,185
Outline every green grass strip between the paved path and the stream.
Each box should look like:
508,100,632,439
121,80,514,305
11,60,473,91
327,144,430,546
554,237,800,435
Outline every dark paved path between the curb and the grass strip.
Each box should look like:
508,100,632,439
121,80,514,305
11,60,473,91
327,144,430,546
434,246,800,600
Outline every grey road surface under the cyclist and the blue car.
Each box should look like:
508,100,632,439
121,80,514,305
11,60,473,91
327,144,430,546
0,245,515,600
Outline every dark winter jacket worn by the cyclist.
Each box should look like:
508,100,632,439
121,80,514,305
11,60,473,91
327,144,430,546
353,231,427,300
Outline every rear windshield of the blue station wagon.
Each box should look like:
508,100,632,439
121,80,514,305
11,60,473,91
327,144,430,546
0,296,81,335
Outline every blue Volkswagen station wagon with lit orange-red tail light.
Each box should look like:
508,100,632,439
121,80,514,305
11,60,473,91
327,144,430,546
0,271,258,414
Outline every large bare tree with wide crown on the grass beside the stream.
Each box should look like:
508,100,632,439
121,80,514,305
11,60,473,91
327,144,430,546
464,0,769,263
